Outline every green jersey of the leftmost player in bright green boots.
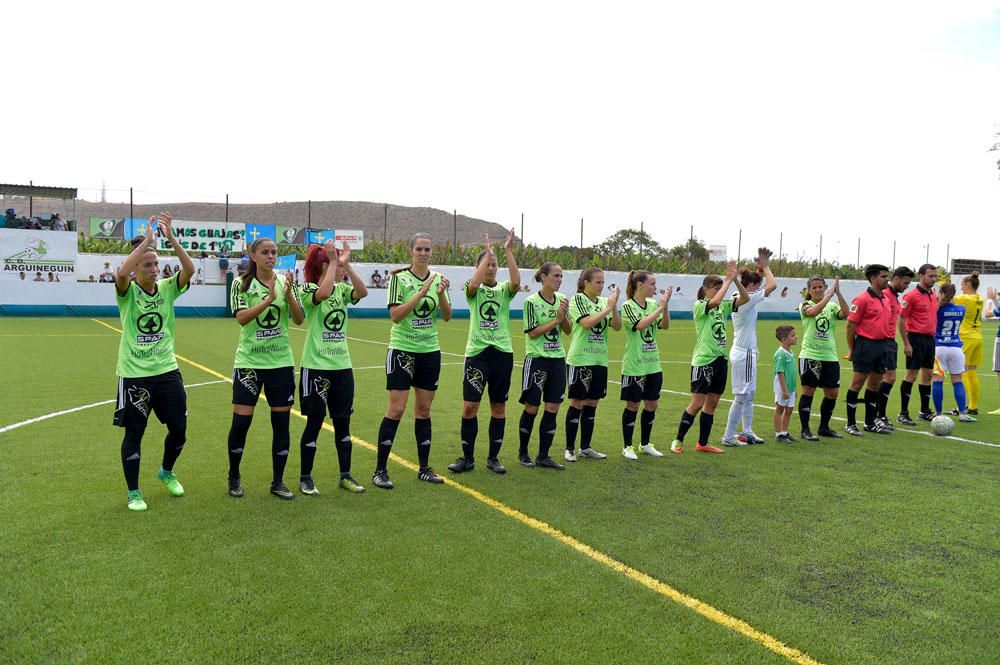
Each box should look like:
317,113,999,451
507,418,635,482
115,275,190,379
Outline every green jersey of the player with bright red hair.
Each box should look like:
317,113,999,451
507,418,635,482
302,282,358,369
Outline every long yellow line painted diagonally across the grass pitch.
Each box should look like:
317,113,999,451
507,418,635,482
91,319,823,665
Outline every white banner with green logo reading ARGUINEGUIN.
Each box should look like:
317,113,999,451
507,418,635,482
0,229,76,282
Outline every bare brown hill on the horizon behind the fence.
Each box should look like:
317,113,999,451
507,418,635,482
5,197,510,245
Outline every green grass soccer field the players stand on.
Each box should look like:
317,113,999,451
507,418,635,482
0,318,1000,664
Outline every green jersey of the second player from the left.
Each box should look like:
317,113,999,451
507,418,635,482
229,274,295,369
